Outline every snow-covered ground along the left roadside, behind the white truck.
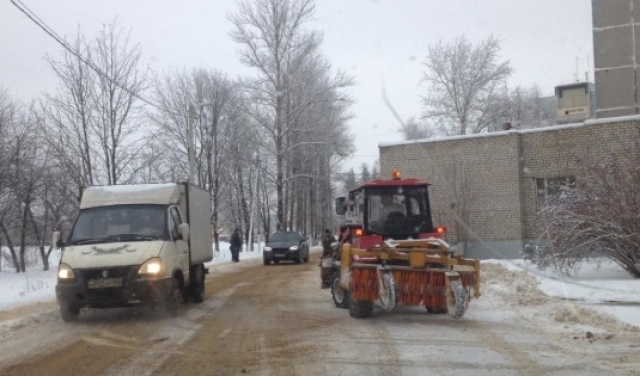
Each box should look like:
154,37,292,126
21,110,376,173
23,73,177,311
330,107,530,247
0,242,263,310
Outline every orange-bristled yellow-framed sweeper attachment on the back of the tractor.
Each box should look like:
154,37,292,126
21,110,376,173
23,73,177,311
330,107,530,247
339,239,480,319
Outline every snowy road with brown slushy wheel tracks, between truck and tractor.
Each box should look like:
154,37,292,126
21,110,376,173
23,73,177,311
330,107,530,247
0,248,640,376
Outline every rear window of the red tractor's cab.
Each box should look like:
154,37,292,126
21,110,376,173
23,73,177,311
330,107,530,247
366,187,433,236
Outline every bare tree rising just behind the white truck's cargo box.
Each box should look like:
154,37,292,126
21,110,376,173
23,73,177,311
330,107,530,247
152,69,241,251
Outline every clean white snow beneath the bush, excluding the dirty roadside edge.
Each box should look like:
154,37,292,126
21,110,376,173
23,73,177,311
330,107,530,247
483,259,640,327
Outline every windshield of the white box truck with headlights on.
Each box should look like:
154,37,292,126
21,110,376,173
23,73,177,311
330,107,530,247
69,205,167,244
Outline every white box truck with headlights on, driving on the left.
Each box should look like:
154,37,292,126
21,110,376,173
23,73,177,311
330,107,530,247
53,183,213,322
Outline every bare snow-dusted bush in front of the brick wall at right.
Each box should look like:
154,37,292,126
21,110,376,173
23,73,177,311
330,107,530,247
538,145,640,278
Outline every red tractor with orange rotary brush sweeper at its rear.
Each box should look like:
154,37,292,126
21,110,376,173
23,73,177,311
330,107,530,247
321,170,480,319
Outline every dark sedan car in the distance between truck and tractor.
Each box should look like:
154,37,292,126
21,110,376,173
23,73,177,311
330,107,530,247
262,231,309,265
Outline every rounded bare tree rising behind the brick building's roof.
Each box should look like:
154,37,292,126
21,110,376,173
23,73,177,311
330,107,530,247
421,37,512,135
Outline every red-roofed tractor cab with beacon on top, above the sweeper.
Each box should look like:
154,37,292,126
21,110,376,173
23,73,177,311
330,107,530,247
336,170,444,248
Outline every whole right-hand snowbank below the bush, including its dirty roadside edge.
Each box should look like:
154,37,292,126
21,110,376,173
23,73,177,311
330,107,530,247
482,260,640,331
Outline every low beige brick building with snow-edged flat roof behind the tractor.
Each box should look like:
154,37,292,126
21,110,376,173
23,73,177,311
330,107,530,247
379,116,640,258
